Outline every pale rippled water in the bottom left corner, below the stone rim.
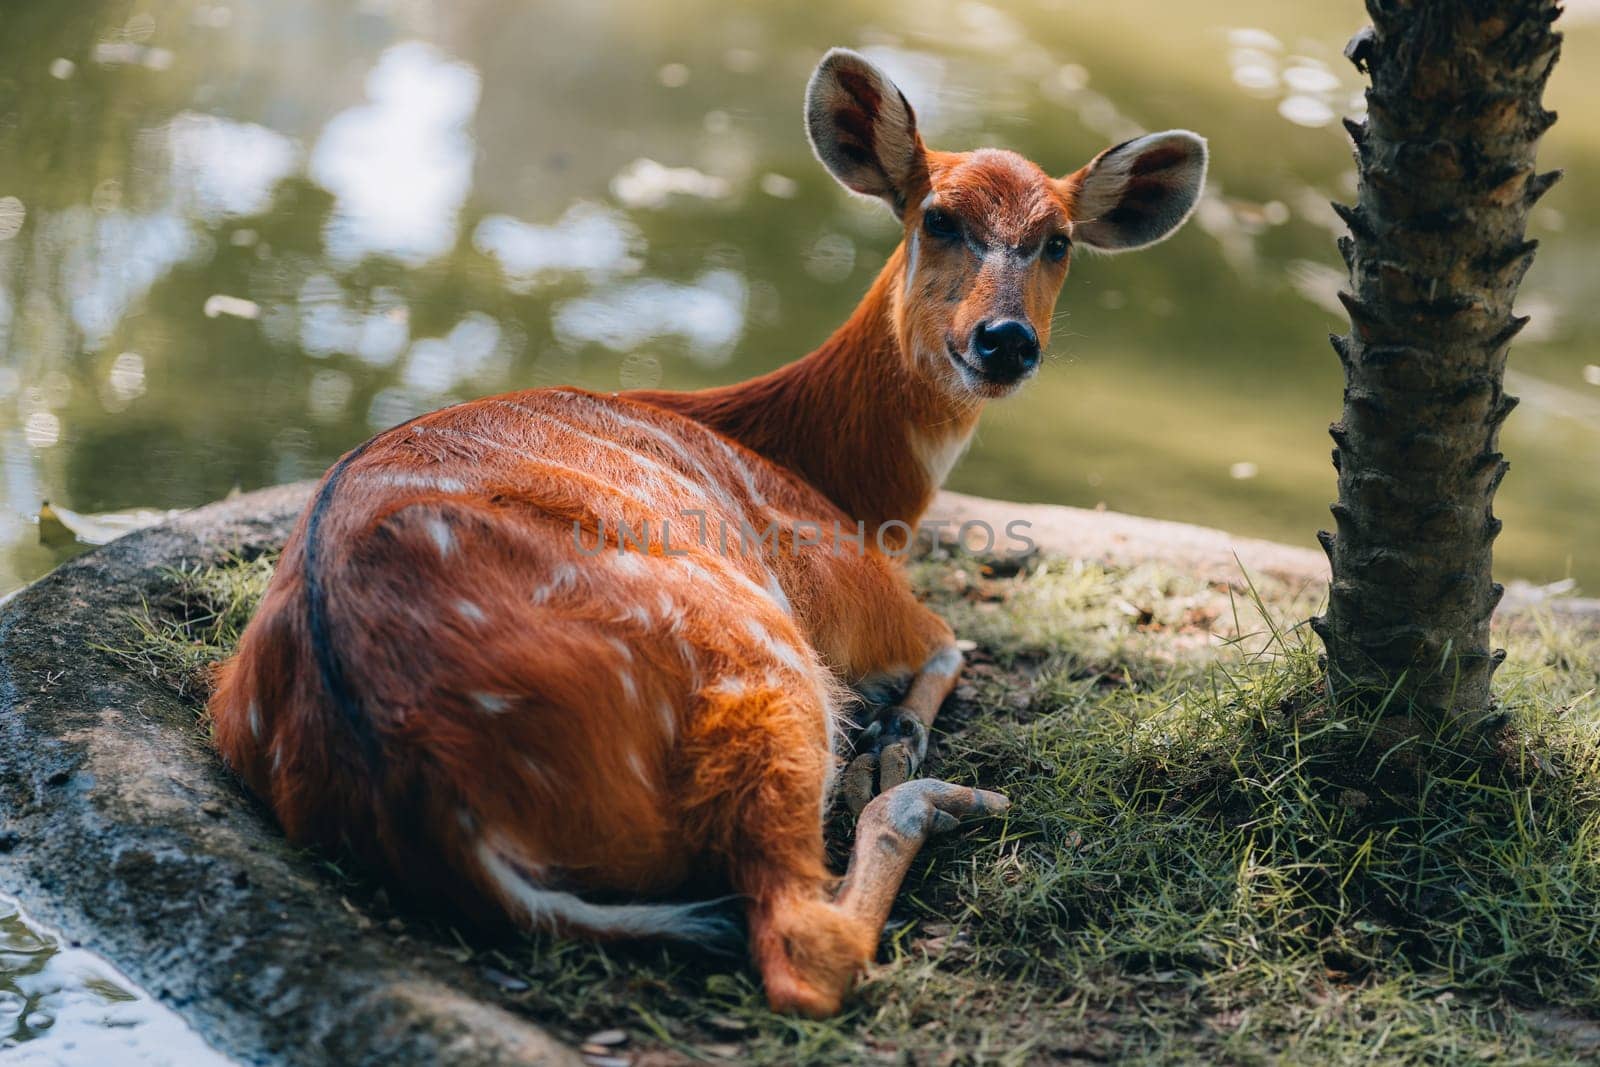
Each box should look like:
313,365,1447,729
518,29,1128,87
0,894,230,1067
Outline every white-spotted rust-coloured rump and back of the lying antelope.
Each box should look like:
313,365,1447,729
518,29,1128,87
211,390,842,933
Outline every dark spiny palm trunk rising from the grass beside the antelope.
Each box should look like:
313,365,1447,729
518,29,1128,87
1312,0,1560,733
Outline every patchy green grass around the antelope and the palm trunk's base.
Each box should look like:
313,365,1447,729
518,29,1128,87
112,547,1600,1064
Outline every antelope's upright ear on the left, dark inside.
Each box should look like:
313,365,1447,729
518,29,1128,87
805,48,928,214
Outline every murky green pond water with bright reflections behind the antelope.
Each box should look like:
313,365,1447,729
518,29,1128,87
0,0,1600,1062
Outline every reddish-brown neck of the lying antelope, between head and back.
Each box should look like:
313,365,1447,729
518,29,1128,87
627,245,978,536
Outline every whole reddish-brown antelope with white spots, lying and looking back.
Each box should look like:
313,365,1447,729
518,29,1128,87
208,50,1206,1017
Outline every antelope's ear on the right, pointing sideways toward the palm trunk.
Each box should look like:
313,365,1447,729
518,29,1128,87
1061,130,1206,251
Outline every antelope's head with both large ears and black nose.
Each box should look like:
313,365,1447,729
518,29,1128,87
806,48,1206,398
